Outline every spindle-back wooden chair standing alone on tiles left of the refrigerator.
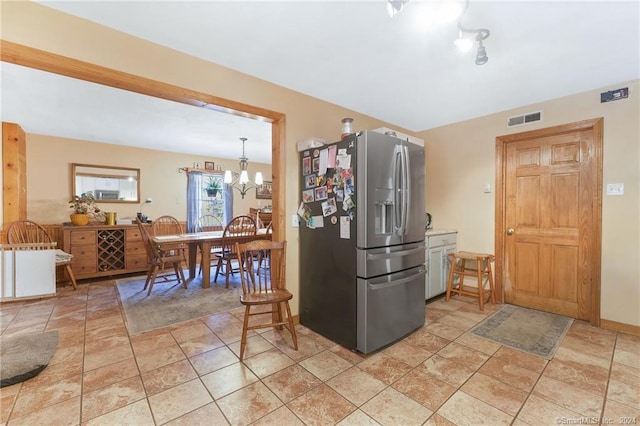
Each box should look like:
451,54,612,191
234,240,298,361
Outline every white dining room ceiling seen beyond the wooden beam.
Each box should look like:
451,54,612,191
0,62,271,164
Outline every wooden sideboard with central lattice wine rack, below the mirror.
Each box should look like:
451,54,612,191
62,225,147,279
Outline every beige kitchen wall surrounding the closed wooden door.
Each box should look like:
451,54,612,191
418,81,640,326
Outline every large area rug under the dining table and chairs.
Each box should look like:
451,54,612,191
116,277,242,335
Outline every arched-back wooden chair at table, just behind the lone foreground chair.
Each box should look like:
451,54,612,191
213,215,256,288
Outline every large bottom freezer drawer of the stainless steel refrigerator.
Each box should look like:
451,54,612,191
356,266,425,354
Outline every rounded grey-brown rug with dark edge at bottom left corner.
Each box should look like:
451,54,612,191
0,330,58,388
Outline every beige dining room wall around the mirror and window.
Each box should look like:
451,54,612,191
27,134,271,224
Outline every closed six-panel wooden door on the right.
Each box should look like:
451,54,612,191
496,119,602,325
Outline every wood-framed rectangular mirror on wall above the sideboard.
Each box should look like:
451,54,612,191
71,163,140,203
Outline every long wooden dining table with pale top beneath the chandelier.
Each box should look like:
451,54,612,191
150,228,273,288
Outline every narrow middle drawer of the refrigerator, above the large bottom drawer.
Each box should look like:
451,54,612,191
356,241,426,278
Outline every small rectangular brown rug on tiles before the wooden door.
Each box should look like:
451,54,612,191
471,305,573,359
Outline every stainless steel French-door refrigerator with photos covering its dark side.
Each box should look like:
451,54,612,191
298,131,425,353
